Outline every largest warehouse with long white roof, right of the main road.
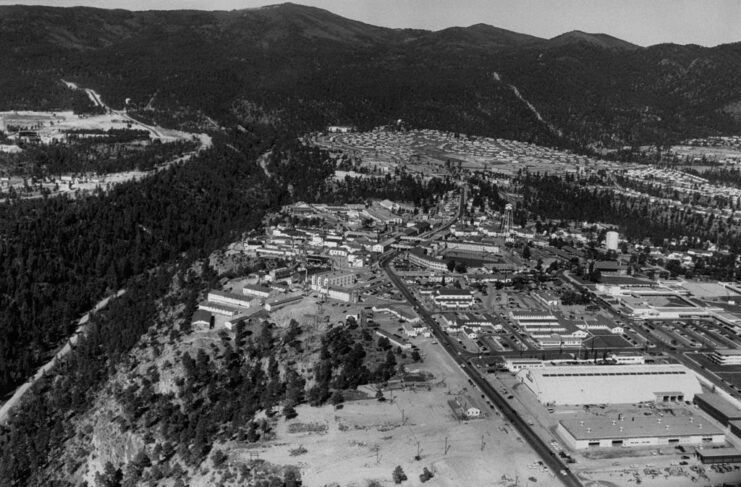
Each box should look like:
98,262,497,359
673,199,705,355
517,364,702,405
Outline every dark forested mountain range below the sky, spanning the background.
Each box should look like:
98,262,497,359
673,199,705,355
0,4,741,147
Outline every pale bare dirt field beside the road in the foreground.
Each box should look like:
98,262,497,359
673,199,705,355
231,339,560,487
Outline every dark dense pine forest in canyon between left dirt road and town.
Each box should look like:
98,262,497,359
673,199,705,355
0,127,332,400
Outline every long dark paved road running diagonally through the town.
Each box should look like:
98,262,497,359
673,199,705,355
379,188,582,487
